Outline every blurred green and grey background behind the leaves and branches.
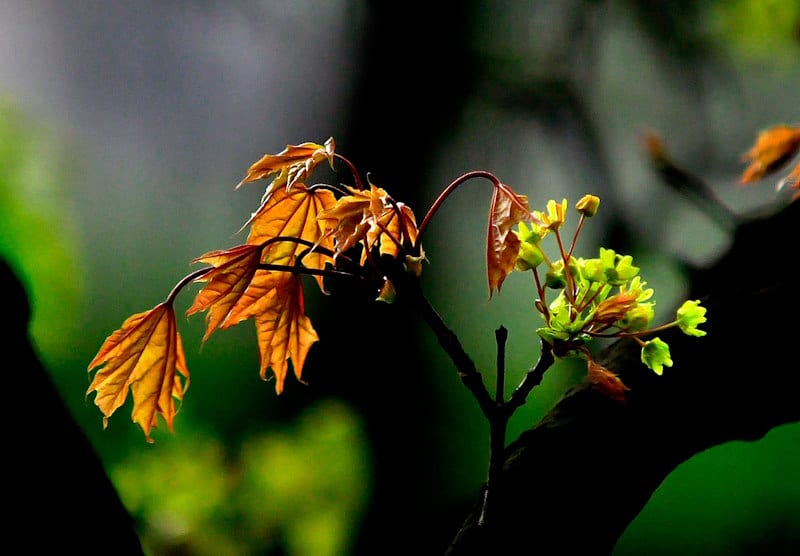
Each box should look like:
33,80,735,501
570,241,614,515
0,0,800,556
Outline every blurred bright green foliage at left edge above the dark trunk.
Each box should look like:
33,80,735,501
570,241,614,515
0,99,83,358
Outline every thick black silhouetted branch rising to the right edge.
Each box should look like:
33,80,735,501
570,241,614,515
448,203,800,556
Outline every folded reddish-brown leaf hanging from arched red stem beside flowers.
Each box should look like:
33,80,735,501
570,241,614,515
486,187,532,297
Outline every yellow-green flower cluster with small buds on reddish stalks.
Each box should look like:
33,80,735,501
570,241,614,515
514,195,706,374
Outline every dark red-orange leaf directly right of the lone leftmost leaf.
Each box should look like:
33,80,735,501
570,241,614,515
186,245,261,342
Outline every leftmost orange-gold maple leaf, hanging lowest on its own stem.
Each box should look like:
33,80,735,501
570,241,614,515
86,301,189,442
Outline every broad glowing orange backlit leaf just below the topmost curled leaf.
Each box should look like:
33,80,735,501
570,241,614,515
247,183,336,290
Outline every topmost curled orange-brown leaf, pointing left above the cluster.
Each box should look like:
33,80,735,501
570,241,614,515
236,137,336,194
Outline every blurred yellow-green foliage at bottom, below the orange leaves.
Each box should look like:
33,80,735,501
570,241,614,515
112,401,372,556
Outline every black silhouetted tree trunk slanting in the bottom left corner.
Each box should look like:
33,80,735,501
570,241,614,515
6,260,143,556
